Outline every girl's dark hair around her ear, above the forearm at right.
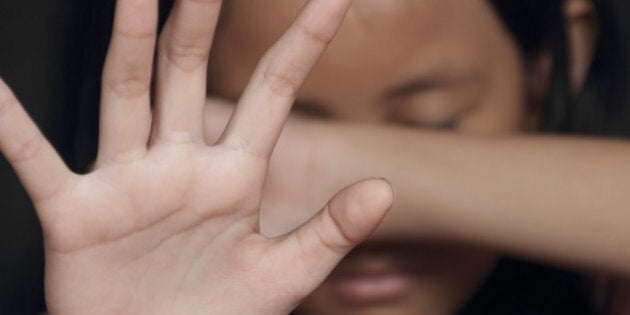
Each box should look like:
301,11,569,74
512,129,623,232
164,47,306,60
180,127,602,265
490,0,630,137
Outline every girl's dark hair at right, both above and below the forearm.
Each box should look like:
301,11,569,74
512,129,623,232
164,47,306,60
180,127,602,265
460,0,630,315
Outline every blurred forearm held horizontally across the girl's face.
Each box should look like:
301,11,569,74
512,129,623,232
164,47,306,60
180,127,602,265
325,125,630,274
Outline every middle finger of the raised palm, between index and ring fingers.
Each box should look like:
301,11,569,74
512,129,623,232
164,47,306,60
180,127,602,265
153,0,221,142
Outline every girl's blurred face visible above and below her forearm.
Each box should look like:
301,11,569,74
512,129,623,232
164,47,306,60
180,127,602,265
209,0,529,315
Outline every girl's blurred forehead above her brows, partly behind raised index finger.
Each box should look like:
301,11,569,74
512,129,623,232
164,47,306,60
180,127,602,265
211,0,509,100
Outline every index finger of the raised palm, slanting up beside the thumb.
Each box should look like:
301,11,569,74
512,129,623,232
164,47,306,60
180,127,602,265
220,0,352,159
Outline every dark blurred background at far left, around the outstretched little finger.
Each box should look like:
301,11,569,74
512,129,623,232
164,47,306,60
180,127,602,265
0,0,106,314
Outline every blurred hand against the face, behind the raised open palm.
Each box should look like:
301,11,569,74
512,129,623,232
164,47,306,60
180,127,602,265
204,98,344,236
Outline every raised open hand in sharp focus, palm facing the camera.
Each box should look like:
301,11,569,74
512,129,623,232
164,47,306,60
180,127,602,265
0,0,392,314
